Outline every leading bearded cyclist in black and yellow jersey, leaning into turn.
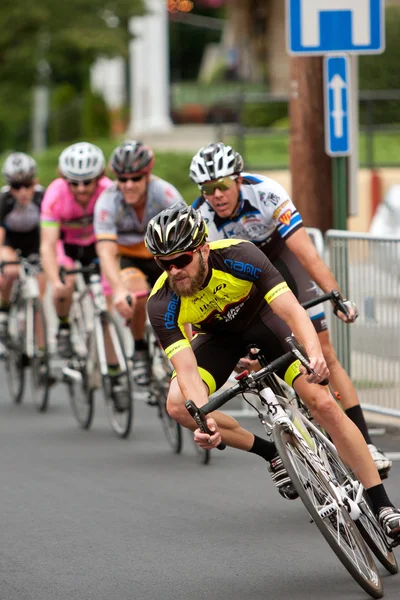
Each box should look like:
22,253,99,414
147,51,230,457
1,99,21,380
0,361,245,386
145,207,400,538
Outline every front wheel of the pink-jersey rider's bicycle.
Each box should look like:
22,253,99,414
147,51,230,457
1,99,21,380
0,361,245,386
101,312,133,439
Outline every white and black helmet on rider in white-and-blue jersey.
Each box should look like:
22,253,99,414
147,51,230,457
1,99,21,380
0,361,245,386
190,142,243,185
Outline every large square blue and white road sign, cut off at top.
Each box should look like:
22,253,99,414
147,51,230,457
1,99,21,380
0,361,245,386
286,0,385,55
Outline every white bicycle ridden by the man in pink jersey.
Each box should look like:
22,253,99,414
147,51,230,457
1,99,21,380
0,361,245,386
60,263,133,438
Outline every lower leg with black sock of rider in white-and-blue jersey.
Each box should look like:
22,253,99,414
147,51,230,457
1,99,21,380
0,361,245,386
318,330,392,477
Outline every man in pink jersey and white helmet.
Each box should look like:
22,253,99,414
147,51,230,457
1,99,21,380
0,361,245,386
40,142,112,358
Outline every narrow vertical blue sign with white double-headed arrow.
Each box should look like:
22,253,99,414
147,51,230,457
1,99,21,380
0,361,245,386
324,56,351,156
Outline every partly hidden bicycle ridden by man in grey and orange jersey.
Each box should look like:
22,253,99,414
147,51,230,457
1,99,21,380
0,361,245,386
146,323,211,465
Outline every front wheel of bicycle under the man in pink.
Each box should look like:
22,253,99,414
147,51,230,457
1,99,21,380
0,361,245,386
97,312,133,438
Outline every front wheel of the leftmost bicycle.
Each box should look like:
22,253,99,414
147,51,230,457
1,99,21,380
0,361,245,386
29,298,50,412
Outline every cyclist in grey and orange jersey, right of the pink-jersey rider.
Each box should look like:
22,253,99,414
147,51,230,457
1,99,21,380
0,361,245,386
94,140,185,385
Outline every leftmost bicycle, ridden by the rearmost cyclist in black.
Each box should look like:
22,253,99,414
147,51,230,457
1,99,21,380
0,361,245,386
0,255,53,412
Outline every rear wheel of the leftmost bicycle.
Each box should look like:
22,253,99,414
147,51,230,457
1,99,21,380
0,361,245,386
4,294,28,404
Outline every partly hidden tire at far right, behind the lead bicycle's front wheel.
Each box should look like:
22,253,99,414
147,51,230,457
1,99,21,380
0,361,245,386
318,436,399,575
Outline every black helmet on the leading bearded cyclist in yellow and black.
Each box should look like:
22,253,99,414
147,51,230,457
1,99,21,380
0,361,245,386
145,203,208,256
